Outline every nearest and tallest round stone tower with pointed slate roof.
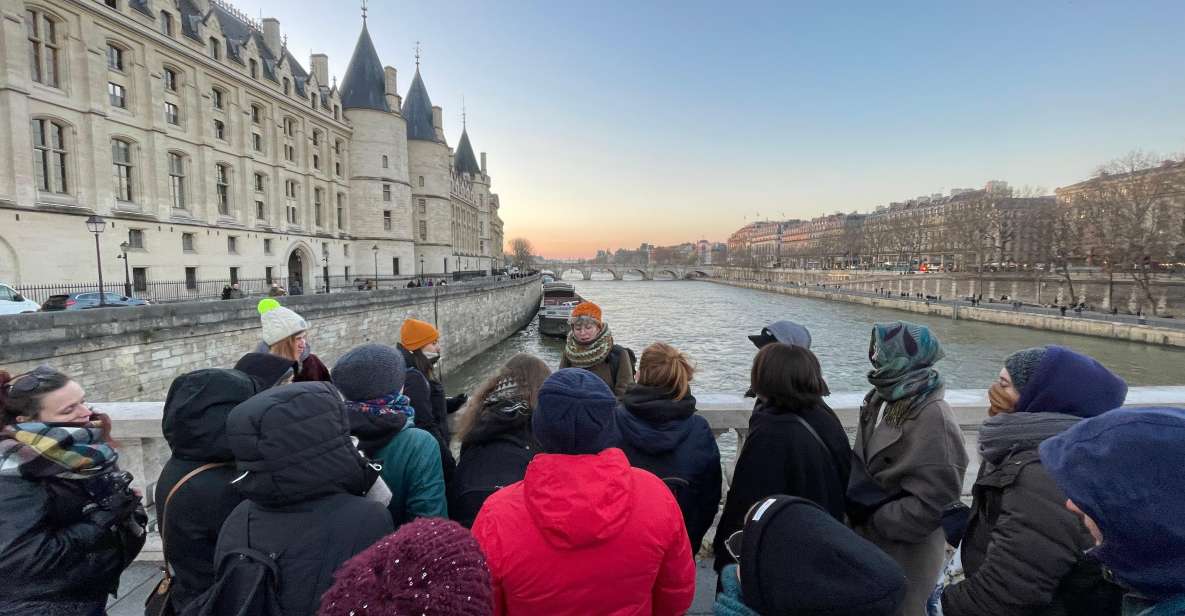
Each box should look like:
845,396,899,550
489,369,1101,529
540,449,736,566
341,15,415,276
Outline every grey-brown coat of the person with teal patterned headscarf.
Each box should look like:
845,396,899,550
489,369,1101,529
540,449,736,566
852,390,967,616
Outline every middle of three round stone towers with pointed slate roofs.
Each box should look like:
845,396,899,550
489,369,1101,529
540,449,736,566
403,63,456,275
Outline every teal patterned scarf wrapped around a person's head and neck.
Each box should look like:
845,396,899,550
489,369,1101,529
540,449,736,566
867,321,944,425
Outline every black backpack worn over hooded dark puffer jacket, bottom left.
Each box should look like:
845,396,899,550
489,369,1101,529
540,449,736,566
180,506,303,616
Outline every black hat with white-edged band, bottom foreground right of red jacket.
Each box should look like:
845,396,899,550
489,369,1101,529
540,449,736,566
739,495,905,616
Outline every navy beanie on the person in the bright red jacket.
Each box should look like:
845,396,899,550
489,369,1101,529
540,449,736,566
531,368,619,454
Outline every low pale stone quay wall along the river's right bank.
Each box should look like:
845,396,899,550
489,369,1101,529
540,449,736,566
713,278,1185,348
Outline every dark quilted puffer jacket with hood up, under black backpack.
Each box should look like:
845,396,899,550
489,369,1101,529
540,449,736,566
214,381,392,616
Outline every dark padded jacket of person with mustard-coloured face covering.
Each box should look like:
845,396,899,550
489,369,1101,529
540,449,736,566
942,449,1122,616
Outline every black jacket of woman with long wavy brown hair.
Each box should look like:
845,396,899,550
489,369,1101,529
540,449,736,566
448,400,539,528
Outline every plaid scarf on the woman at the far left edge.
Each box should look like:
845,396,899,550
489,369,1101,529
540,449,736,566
0,422,119,480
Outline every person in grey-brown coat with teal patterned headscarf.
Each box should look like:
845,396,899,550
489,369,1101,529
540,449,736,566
847,321,967,615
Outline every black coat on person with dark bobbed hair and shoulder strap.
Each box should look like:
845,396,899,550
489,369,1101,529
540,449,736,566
712,399,852,571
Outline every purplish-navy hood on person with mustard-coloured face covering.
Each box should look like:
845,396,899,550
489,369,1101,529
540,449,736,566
1016,345,1127,417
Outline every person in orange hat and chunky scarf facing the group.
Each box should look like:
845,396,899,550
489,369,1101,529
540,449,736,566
559,300,634,400
